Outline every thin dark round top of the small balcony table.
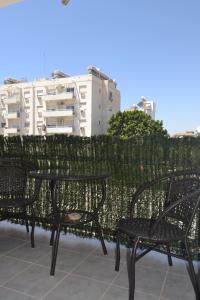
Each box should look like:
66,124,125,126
29,169,110,181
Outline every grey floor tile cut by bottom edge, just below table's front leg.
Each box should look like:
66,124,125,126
45,276,108,300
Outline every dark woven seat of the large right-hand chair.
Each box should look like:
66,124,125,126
117,218,185,242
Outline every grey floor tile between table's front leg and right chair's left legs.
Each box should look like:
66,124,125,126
74,255,117,283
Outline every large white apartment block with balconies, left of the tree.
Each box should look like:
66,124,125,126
0,66,120,136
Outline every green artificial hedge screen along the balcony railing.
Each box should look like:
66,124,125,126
0,135,200,254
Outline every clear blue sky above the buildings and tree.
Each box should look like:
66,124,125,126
0,0,200,133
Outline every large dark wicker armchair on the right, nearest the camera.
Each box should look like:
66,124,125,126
115,171,200,300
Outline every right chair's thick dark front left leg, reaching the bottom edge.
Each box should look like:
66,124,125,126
129,238,139,300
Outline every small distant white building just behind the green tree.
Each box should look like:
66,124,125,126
126,96,156,120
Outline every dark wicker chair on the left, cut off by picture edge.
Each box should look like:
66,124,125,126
0,160,41,248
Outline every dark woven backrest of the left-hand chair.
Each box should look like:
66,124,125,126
0,164,27,198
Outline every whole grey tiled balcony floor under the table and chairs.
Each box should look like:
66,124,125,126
0,222,198,300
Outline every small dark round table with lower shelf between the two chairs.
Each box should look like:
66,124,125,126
50,174,109,275
